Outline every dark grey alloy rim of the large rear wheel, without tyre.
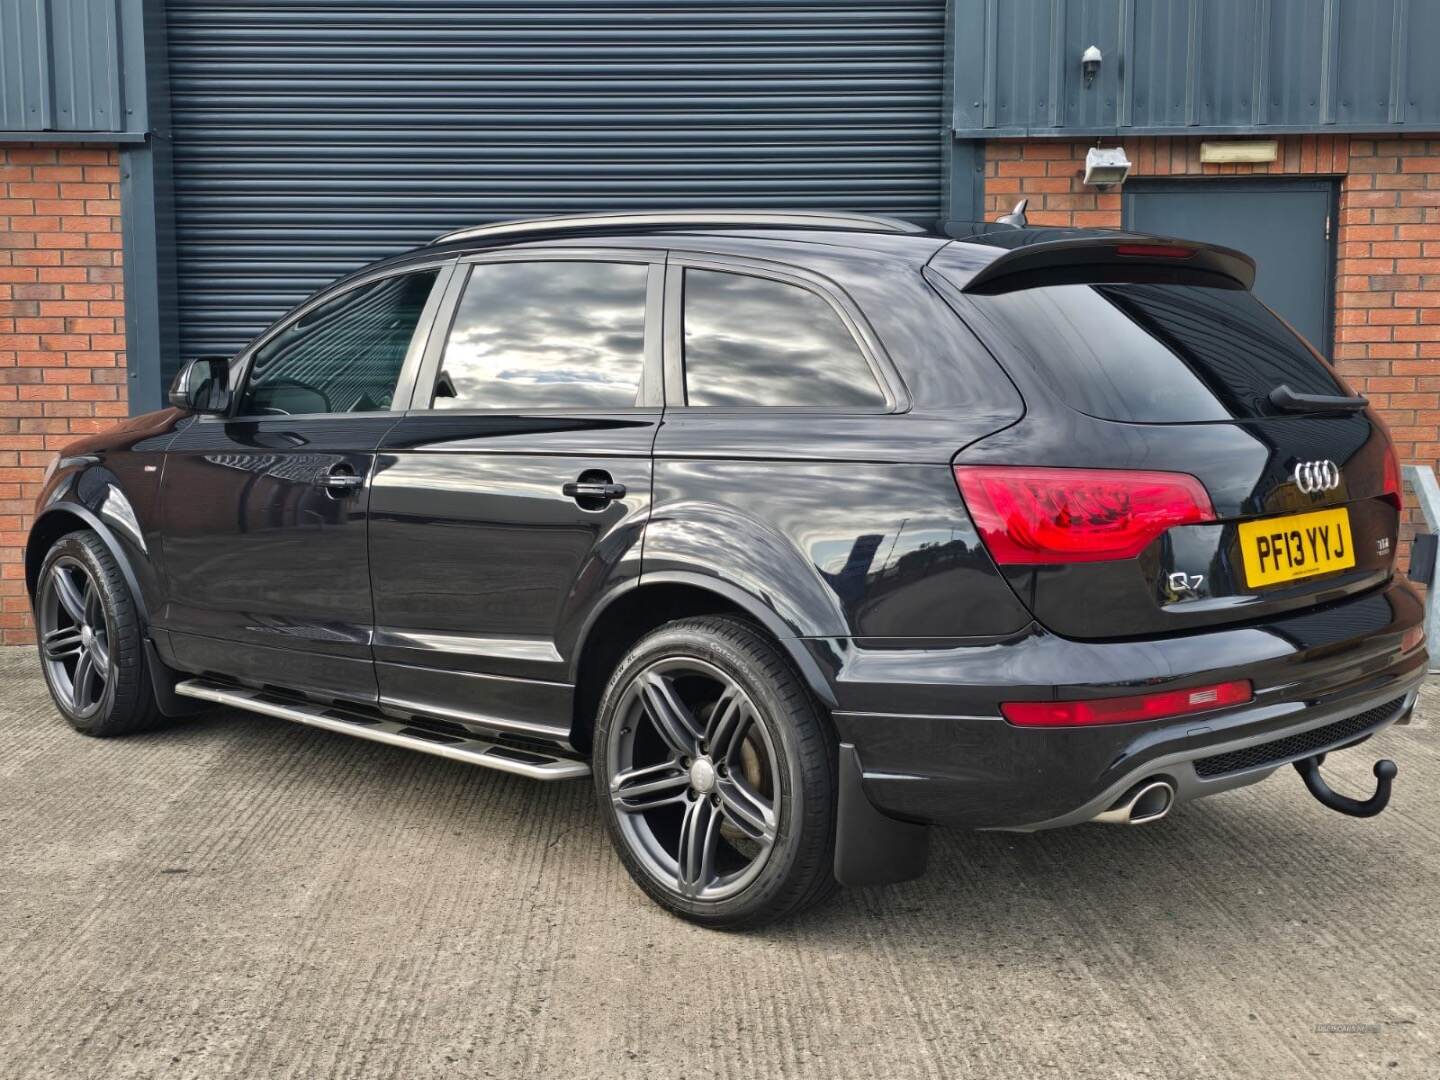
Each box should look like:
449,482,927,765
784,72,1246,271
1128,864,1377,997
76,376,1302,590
606,657,782,900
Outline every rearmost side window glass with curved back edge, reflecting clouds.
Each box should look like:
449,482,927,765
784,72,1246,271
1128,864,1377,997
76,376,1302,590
685,269,886,409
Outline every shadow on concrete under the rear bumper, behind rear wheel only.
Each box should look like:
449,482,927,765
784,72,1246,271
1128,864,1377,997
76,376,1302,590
804,769,1428,943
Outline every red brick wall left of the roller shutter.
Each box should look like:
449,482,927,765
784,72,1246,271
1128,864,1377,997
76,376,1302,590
0,145,128,644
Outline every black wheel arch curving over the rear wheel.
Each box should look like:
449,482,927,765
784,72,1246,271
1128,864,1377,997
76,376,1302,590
570,570,835,750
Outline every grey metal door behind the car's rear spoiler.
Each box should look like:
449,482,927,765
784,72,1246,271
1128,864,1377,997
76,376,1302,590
1123,180,1335,356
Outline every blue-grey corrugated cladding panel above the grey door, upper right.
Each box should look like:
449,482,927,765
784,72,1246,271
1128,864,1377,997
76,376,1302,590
952,0,1440,138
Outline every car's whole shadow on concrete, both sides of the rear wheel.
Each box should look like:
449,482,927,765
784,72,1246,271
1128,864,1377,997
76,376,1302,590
185,710,1426,949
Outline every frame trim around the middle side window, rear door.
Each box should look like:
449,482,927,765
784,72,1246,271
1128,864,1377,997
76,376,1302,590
405,246,665,416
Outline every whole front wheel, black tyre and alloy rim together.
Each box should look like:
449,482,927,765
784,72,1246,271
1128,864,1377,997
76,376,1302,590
35,531,164,737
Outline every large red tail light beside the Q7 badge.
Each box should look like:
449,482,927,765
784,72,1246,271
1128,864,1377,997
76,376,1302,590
955,465,1215,566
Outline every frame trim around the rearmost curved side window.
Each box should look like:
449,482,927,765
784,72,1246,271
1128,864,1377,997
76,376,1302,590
664,251,910,416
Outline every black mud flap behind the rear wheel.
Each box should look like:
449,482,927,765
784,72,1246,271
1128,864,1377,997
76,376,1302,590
835,743,930,886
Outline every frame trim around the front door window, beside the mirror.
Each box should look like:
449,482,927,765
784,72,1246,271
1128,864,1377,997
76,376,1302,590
213,256,456,423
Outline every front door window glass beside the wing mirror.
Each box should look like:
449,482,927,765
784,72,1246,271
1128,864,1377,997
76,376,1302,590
239,271,436,416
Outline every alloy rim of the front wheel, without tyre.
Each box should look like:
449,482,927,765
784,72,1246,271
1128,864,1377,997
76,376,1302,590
37,557,114,717
